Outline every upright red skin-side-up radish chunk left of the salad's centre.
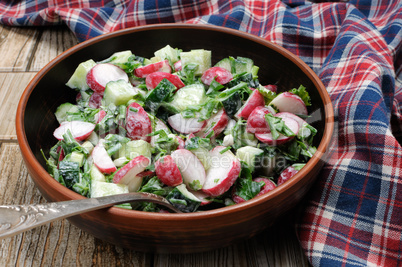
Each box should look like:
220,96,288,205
126,102,152,142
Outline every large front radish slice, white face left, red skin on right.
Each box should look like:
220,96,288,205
202,146,241,196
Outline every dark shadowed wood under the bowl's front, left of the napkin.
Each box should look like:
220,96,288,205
154,222,309,267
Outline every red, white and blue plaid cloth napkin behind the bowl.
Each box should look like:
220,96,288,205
0,0,402,266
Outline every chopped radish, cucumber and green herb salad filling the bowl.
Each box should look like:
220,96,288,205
44,45,317,212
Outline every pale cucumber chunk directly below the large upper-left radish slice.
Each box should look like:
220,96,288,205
102,80,139,106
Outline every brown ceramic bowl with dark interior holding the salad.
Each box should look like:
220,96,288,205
16,24,333,253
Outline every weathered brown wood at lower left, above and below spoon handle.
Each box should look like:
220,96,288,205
0,143,151,267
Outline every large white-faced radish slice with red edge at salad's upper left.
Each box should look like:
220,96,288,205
86,63,128,94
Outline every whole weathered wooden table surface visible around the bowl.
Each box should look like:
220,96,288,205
0,26,309,267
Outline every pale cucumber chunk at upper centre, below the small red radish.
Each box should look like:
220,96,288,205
170,84,206,111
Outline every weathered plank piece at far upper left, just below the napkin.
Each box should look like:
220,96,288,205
0,25,39,72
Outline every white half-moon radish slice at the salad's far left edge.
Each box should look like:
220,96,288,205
53,121,95,141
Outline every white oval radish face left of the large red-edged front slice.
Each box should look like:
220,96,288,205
171,149,205,190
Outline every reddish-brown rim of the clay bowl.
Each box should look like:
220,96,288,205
16,23,334,220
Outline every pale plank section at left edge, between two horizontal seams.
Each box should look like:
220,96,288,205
0,72,35,141
